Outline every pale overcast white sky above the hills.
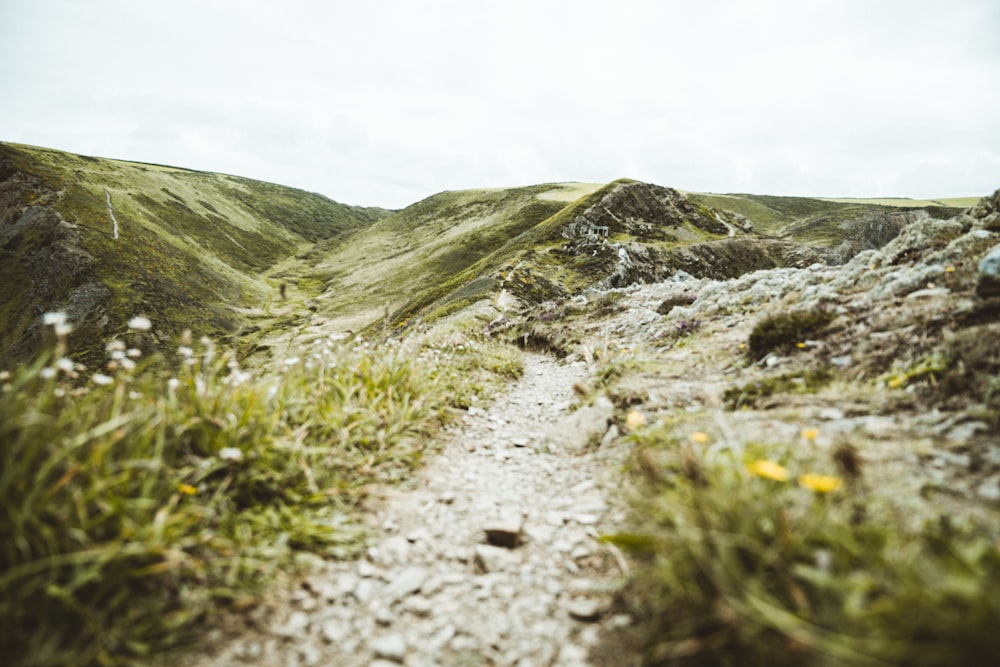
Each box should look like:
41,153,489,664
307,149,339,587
0,0,1000,208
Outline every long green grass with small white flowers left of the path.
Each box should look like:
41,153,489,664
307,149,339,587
0,319,521,666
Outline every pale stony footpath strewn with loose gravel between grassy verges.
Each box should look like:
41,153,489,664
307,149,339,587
198,355,628,667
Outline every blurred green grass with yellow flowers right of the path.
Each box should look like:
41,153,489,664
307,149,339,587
607,424,1000,666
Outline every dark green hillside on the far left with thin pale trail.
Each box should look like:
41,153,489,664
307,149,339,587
0,144,389,368
